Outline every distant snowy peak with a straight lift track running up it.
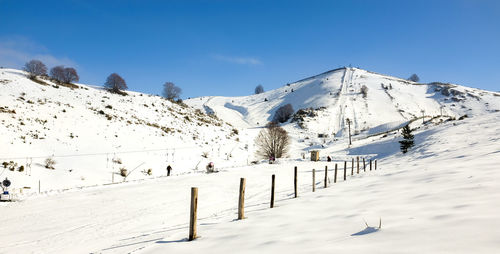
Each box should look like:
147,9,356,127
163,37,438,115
186,68,500,137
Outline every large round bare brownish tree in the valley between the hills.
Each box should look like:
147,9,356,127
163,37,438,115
255,122,290,159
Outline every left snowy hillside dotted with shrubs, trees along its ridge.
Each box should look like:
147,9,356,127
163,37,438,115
0,69,247,193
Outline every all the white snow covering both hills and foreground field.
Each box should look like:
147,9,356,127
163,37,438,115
0,68,500,253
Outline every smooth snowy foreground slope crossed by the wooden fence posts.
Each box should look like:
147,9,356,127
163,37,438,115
0,110,500,253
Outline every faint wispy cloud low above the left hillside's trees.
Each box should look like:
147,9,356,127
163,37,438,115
0,36,78,69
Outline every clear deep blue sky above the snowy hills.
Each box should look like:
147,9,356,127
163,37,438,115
0,0,500,98
